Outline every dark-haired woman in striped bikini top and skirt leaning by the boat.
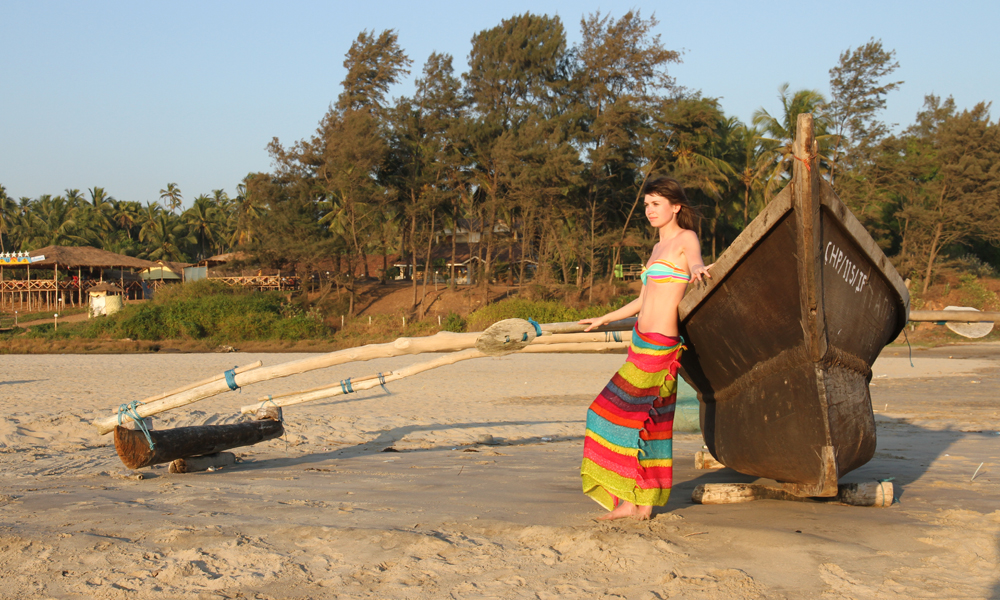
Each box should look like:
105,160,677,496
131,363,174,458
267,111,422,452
580,177,711,520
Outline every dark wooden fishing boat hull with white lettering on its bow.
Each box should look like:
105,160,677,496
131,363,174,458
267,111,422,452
680,115,910,496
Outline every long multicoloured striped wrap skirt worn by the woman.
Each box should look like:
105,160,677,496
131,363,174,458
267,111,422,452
580,327,684,510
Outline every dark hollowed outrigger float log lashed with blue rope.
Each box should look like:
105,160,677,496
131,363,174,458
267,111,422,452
114,419,285,469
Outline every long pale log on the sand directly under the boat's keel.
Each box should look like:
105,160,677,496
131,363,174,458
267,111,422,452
691,481,893,508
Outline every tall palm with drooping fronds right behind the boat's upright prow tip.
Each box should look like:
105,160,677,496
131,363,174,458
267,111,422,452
753,83,831,198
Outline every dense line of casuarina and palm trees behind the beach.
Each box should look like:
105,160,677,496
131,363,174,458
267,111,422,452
0,11,1000,305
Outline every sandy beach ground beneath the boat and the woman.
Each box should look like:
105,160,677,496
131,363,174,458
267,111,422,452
0,345,1000,600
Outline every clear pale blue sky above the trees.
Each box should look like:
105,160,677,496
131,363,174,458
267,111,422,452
0,0,1000,205
